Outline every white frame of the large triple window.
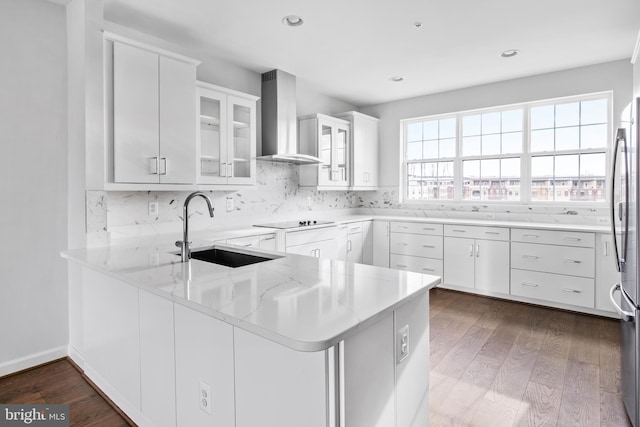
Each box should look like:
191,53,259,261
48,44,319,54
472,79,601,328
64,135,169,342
399,90,613,207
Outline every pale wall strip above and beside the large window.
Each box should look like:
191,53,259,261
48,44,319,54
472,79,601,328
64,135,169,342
360,60,632,187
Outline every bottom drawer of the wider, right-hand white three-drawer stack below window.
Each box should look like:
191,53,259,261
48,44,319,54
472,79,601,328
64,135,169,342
511,269,594,308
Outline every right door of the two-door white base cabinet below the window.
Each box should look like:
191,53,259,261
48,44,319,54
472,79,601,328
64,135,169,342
474,240,510,295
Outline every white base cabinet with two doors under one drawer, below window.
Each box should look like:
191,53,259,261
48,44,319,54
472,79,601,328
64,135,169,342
443,226,510,294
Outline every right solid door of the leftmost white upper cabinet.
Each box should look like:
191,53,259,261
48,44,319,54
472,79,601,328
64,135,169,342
159,56,196,184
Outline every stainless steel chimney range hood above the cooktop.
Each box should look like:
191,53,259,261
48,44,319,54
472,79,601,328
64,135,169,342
257,70,323,165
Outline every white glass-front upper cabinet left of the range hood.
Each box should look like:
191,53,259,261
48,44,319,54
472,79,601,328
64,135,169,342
197,82,258,185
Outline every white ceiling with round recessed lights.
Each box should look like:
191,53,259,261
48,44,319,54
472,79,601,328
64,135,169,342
104,0,640,107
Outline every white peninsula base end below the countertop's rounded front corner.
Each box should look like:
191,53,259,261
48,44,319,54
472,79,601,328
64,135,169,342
234,293,429,427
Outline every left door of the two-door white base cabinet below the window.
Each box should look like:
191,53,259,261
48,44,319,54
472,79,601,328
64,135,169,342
444,237,475,289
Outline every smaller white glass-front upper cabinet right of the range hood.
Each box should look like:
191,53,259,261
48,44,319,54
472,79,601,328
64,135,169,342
298,114,351,190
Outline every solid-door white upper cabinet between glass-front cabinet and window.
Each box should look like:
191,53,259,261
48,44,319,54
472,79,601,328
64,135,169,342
336,111,380,191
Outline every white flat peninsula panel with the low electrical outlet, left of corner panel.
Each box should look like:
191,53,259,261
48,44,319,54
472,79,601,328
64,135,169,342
174,304,236,426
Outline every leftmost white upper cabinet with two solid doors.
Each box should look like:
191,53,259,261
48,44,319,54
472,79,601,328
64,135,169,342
106,39,198,184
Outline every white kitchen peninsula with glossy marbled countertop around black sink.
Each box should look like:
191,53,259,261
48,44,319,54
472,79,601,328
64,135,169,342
63,237,440,427
